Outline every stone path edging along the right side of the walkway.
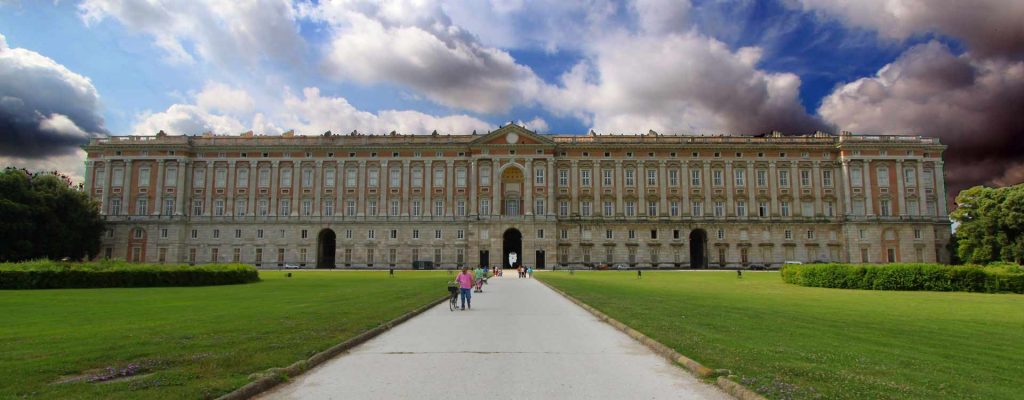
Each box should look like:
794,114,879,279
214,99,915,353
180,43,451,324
536,279,767,400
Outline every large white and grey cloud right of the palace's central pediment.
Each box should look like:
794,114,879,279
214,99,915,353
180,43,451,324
542,32,827,133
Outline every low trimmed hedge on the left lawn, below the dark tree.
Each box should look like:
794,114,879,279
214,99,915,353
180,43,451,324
0,260,259,290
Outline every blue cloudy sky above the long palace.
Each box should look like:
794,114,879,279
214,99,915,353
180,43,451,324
0,0,1024,203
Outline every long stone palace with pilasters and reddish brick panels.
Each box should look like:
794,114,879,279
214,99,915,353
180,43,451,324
84,124,950,268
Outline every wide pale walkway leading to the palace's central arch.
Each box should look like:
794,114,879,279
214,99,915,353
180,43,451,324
261,272,730,399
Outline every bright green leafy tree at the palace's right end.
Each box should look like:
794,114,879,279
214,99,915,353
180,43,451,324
949,184,1024,264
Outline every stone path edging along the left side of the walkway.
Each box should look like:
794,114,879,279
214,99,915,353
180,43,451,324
217,295,451,400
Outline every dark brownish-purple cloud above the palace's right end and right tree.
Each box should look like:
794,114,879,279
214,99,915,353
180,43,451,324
818,42,1024,195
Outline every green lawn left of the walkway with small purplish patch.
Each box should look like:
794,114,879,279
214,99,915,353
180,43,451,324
0,271,451,399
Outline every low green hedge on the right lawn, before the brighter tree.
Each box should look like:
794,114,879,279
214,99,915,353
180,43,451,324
781,264,1024,294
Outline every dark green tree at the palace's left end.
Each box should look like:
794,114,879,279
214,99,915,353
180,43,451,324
0,168,105,262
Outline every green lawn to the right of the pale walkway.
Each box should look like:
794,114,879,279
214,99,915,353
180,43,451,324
537,271,1024,399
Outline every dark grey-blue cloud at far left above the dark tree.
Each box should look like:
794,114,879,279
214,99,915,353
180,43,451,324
0,35,106,159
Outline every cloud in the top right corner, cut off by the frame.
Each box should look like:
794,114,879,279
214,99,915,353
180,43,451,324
799,0,1024,56
